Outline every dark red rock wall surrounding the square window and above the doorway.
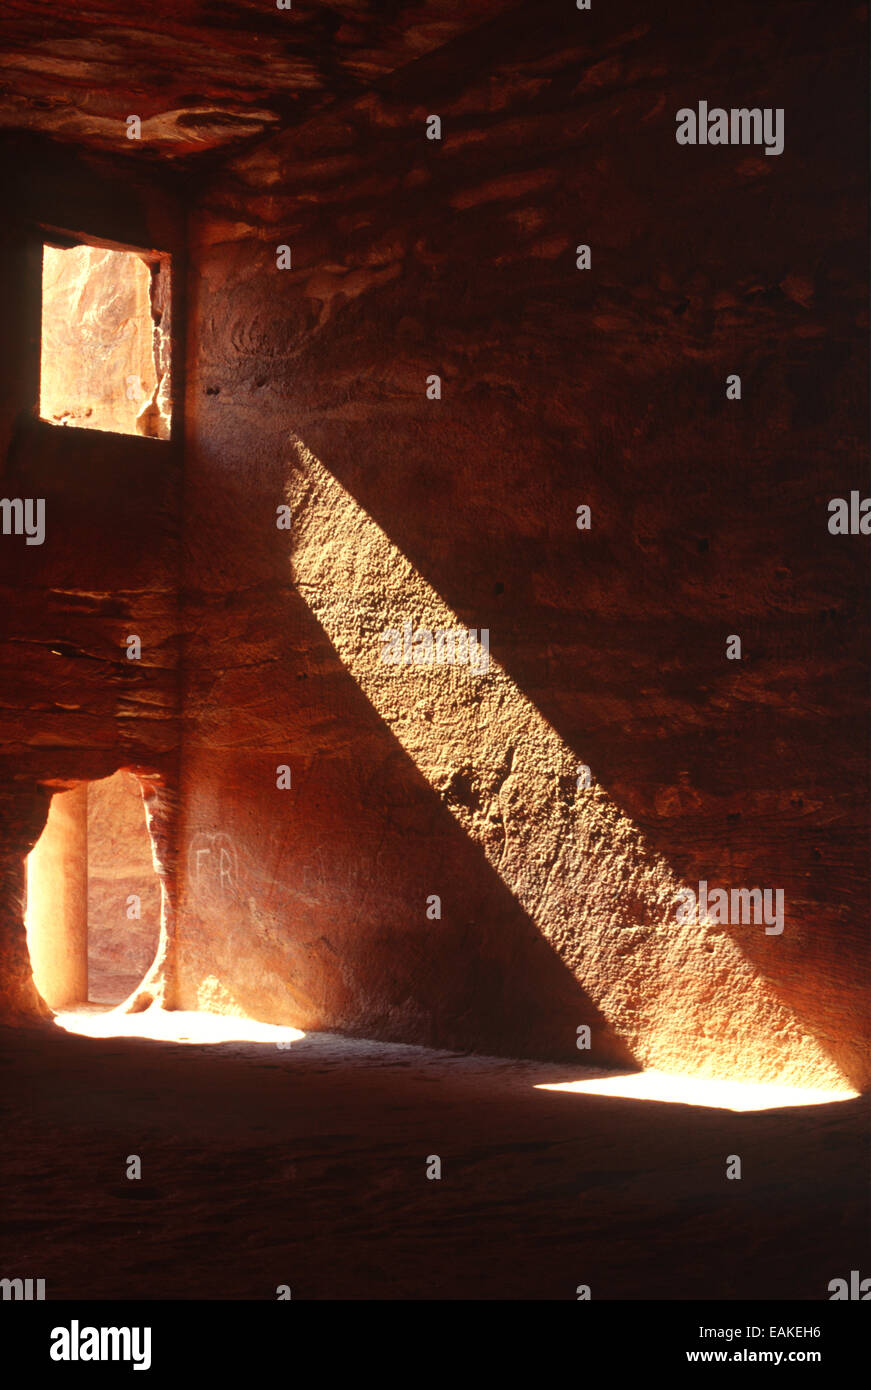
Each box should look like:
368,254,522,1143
0,138,183,1017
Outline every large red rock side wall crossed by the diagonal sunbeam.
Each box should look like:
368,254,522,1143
178,3,868,1084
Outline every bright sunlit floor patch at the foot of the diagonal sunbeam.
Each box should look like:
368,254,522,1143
535,1072,858,1111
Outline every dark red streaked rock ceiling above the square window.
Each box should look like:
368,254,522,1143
0,0,517,160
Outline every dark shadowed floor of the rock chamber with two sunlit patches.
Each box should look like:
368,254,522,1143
0,1011,868,1300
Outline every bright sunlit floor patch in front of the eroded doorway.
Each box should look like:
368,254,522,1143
54,1008,306,1045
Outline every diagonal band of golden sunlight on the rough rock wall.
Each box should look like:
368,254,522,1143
286,439,849,1090
